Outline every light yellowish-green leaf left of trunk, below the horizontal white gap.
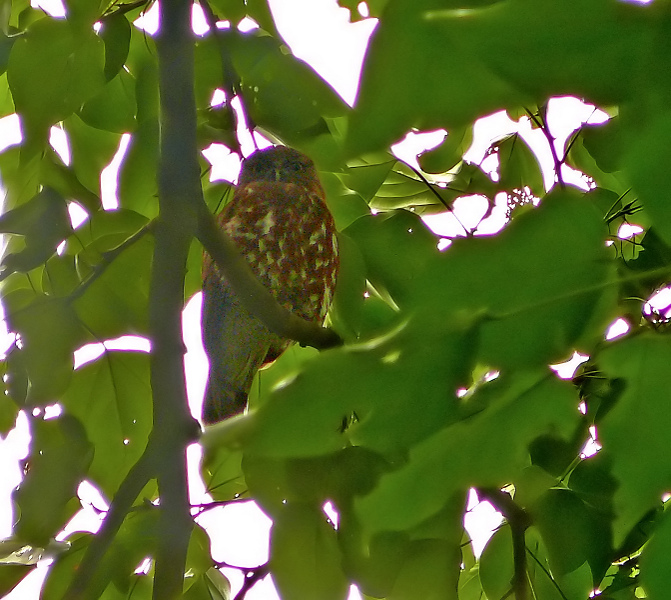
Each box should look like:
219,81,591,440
61,351,152,498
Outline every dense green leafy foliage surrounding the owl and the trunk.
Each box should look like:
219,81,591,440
0,0,671,600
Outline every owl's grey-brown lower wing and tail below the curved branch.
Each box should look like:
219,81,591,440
201,269,281,424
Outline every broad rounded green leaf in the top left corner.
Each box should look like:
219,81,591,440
7,18,105,131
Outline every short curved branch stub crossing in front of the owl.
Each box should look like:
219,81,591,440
197,202,343,350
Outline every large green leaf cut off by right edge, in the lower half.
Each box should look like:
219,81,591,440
599,333,671,545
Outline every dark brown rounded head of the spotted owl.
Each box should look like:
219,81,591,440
238,146,319,188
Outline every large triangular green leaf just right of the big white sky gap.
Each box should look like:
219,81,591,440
348,0,524,153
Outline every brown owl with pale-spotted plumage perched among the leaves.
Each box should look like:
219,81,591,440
201,146,339,424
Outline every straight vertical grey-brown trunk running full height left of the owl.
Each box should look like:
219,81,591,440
149,0,202,600
